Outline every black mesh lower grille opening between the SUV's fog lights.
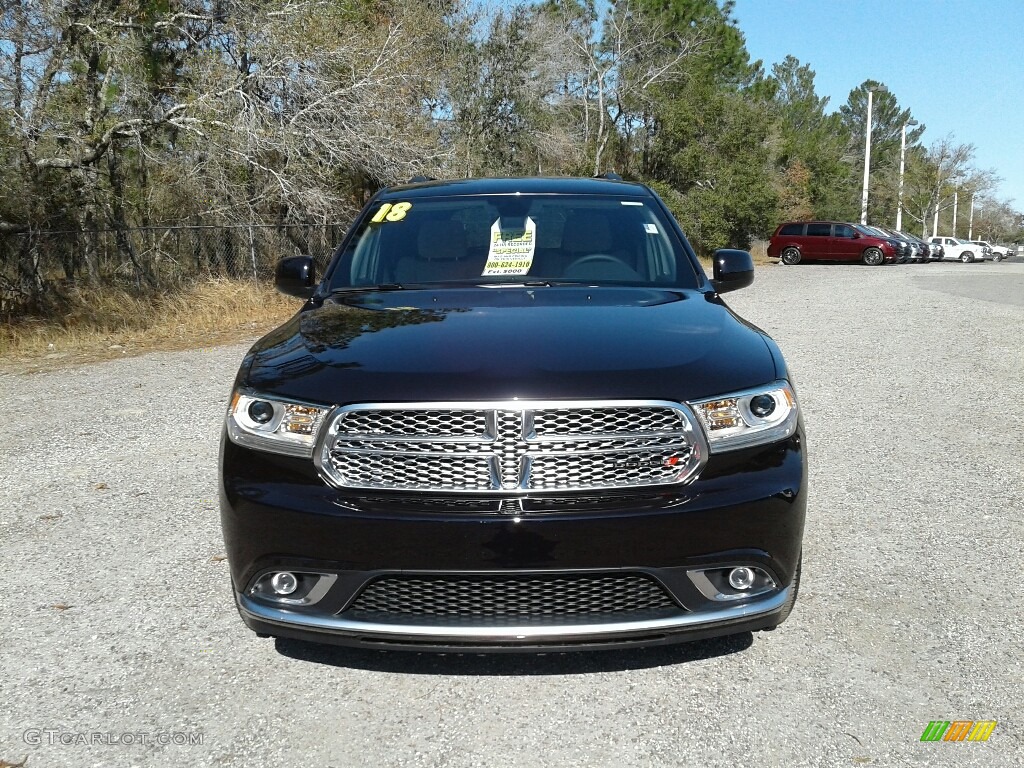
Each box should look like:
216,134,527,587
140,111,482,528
344,573,679,622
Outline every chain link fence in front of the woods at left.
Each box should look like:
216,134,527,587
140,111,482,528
0,223,347,314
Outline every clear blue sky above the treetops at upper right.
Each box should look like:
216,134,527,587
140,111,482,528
733,0,1024,211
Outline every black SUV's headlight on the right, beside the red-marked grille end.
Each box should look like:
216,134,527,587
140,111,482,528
689,381,800,454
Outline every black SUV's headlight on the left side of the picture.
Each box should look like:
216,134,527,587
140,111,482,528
227,392,330,457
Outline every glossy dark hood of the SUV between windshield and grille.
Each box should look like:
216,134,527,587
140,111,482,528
239,287,779,404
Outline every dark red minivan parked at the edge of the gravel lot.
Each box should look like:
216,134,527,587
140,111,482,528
768,221,897,266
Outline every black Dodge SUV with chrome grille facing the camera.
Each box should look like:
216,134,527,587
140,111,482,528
220,178,807,650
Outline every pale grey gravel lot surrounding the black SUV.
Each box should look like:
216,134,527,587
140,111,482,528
0,262,1024,768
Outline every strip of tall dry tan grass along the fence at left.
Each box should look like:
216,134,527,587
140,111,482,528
0,280,300,373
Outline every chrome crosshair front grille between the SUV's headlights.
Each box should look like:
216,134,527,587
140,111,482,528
317,400,708,494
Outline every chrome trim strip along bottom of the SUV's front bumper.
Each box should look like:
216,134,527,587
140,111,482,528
238,587,791,644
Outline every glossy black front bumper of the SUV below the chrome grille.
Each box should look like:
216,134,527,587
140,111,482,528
221,427,807,651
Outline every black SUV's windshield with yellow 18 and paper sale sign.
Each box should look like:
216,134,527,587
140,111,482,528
329,194,698,291
